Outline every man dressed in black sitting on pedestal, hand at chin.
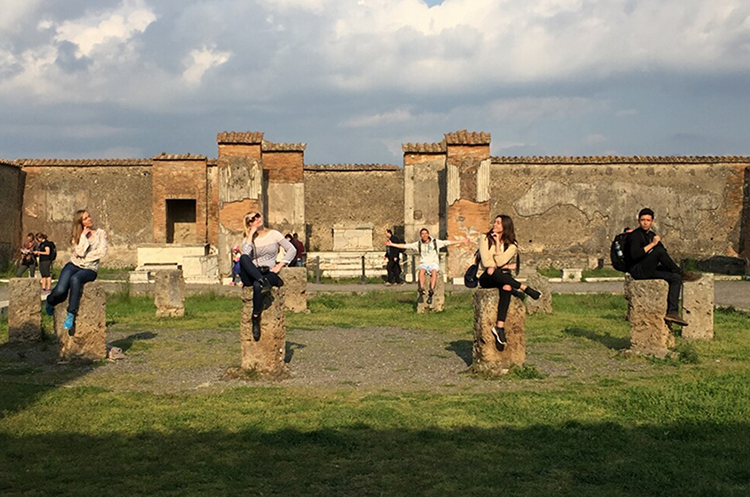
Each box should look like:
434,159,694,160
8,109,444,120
625,208,699,326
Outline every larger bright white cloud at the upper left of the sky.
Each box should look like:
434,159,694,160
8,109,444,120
55,0,156,56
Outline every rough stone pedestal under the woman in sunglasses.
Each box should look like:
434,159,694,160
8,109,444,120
240,285,287,376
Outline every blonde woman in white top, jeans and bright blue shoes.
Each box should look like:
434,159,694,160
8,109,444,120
45,209,107,336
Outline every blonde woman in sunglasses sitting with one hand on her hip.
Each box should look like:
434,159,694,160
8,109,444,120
240,212,297,340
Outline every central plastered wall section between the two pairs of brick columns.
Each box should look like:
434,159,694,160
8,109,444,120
304,165,406,252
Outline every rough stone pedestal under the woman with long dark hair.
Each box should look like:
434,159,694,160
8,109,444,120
471,288,526,375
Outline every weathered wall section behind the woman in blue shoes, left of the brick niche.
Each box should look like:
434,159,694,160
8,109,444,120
16,159,153,267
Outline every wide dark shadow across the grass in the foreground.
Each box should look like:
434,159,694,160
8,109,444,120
0,422,750,496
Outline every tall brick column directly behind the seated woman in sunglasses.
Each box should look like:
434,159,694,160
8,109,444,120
216,132,263,276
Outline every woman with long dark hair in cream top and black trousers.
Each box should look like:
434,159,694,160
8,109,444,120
479,214,542,348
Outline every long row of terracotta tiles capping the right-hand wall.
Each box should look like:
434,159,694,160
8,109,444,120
492,155,750,165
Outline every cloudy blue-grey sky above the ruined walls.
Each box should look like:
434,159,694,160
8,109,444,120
0,0,750,165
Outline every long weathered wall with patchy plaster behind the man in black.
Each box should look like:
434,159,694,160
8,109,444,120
488,157,749,267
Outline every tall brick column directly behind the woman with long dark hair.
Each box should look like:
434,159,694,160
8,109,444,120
445,130,490,278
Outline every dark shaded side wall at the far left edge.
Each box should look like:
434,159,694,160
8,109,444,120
0,160,23,267
